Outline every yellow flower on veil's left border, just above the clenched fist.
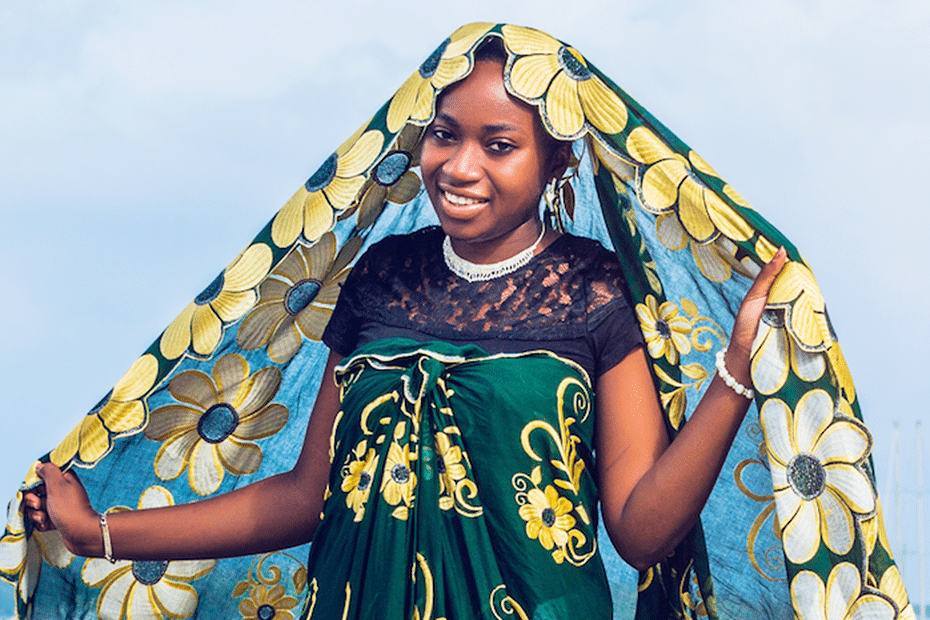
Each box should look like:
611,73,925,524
49,353,158,466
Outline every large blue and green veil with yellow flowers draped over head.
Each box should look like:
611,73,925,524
0,23,915,620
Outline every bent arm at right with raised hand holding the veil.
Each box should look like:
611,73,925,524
597,245,785,569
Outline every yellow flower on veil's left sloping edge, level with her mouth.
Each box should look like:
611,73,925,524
271,129,384,248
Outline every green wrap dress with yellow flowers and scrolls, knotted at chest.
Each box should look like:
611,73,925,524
305,339,612,620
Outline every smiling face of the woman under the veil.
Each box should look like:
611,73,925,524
420,60,564,263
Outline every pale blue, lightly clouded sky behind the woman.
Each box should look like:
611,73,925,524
0,0,930,616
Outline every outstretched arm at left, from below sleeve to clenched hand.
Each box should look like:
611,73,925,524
25,353,340,560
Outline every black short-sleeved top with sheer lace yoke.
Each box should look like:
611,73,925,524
323,227,642,377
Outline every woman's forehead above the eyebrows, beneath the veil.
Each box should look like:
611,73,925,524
436,60,545,136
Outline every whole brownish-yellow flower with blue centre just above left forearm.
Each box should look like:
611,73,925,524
145,353,288,495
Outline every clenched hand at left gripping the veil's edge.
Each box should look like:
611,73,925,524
23,463,102,555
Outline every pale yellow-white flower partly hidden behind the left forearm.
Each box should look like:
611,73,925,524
81,486,216,620
